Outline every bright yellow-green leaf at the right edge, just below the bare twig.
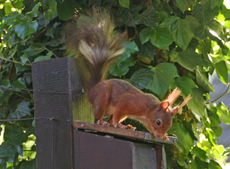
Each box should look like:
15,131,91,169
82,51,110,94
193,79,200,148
216,102,230,124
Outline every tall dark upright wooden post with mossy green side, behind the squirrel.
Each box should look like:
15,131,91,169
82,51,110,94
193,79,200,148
32,58,93,169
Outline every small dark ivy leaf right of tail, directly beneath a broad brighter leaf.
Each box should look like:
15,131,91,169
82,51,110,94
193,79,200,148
135,39,156,60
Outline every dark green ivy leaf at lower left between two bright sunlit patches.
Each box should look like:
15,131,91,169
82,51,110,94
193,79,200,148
4,124,28,146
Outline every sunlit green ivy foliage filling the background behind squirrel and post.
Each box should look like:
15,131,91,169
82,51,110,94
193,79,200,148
0,0,230,169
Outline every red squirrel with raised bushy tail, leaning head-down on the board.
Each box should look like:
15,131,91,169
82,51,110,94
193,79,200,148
66,9,191,140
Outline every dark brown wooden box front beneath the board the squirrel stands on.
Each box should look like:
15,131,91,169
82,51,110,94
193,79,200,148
74,130,157,169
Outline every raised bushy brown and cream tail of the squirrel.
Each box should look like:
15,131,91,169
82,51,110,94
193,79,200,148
66,9,125,88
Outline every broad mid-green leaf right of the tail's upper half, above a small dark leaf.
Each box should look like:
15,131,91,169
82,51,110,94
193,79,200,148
140,26,173,50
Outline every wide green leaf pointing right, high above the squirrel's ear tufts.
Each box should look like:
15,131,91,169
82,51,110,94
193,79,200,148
170,51,207,71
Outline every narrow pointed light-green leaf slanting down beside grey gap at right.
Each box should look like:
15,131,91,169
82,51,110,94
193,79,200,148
196,67,215,92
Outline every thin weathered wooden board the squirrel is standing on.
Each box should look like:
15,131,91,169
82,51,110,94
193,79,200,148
73,121,177,144
